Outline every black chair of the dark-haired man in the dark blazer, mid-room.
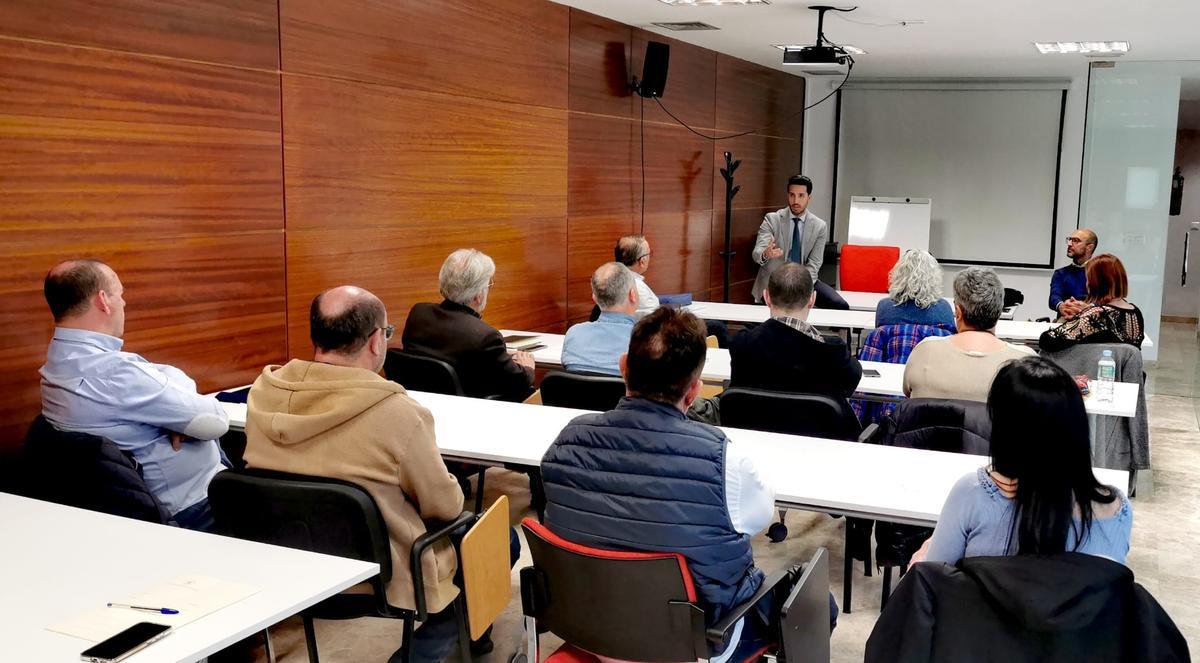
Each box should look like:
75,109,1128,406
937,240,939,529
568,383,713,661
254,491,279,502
720,387,878,613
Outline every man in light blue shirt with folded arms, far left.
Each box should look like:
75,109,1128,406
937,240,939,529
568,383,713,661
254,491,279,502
41,261,229,531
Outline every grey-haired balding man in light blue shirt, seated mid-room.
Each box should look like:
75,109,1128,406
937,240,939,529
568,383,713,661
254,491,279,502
563,262,638,375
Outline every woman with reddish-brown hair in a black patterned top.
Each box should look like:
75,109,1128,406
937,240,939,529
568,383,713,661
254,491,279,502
1038,253,1146,352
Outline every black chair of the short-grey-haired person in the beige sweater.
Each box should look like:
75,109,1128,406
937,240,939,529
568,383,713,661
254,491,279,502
875,399,991,610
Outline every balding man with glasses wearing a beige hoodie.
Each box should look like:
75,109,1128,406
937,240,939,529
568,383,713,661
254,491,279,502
245,286,462,662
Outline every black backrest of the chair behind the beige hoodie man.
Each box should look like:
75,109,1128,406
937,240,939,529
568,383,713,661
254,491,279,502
209,470,391,583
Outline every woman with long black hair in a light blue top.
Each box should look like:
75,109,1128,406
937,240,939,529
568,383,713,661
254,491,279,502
913,357,1133,563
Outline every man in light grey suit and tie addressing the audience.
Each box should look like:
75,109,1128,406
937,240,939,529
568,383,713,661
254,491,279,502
752,175,850,311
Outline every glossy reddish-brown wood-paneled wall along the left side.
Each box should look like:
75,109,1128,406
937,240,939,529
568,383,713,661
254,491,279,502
0,0,804,448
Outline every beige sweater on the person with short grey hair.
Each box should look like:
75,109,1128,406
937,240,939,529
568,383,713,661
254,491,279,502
904,336,1037,402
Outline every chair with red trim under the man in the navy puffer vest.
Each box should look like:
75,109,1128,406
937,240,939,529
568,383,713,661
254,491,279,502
511,518,829,663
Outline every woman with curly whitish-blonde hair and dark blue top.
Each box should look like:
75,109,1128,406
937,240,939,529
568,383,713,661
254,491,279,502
875,249,954,330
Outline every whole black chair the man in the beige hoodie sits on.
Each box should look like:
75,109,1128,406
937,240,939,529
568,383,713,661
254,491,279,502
209,470,475,663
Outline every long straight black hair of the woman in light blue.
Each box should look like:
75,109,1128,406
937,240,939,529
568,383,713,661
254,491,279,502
988,357,1116,555
